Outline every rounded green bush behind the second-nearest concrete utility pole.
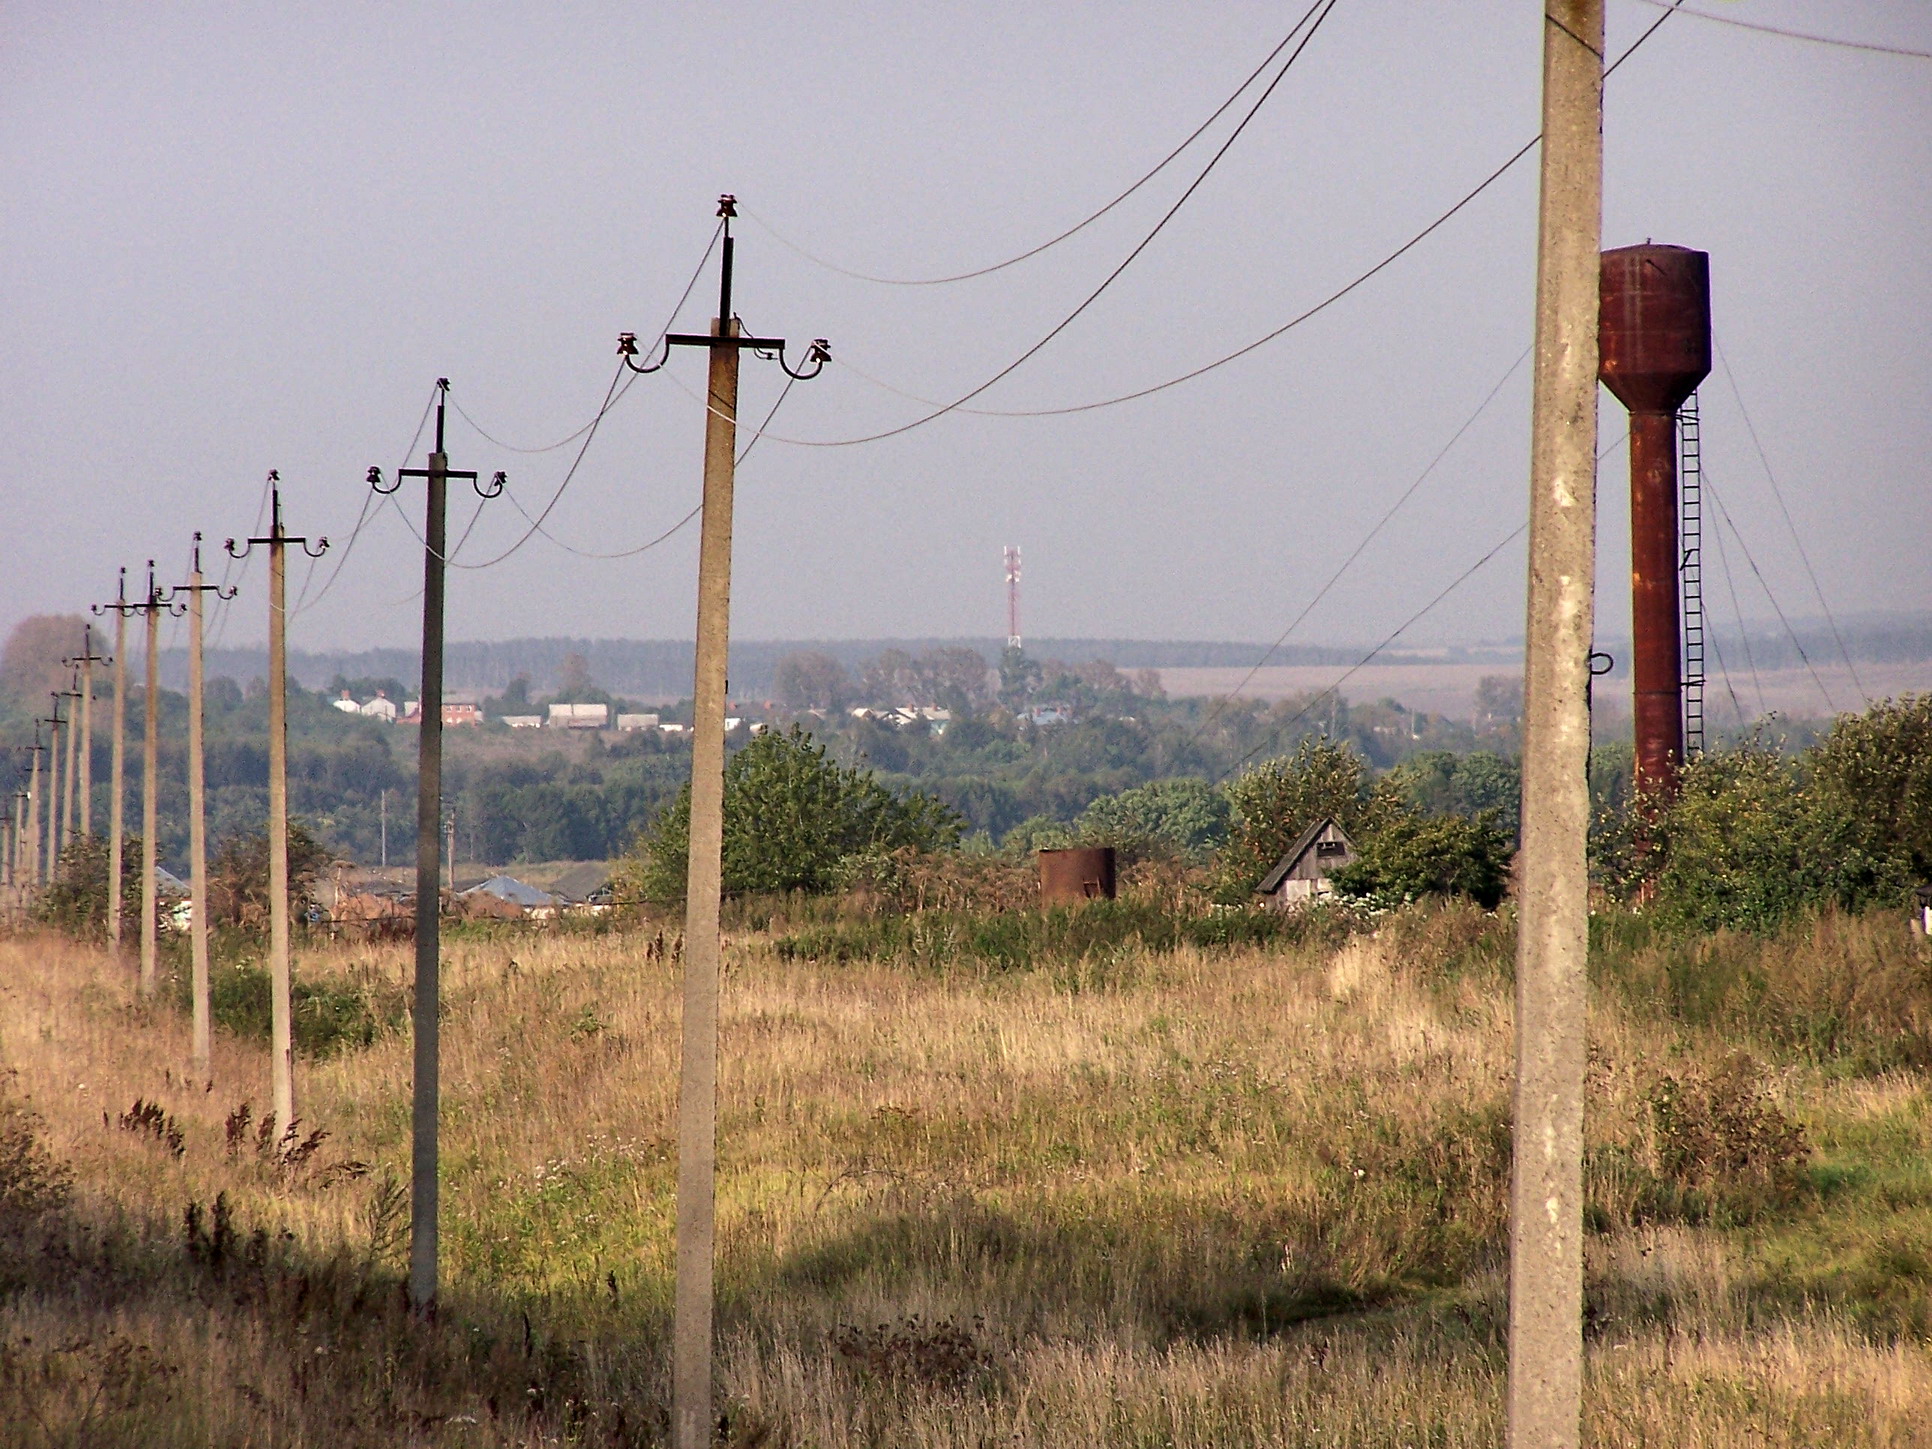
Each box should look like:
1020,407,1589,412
614,726,960,902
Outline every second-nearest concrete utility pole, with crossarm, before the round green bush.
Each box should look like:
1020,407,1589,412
618,195,831,1449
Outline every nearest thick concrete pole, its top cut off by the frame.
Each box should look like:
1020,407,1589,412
1509,0,1604,1449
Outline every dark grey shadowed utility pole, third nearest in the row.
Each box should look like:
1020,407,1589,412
369,377,504,1312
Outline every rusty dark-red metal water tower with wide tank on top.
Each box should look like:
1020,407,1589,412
1598,242,1710,798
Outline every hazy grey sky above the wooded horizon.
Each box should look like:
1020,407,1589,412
0,0,1932,647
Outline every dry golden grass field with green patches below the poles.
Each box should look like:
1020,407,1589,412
0,908,1932,1449
